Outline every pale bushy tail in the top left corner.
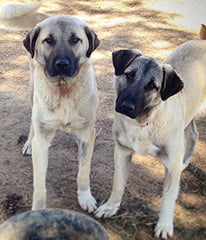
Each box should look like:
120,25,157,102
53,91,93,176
0,2,49,30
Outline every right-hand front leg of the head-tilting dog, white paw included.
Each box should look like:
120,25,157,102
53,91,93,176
155,150,184,239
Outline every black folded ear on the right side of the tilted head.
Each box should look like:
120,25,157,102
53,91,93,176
160,64,184,101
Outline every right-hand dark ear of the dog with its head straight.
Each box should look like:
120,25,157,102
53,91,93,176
85,27,100,58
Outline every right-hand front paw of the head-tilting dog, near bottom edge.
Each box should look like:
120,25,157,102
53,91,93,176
155,221,173,239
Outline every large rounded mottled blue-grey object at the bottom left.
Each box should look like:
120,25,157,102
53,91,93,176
0,209,109,240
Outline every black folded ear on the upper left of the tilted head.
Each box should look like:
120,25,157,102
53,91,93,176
112,50,142,76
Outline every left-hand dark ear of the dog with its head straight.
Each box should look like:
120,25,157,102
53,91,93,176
23,27,40,58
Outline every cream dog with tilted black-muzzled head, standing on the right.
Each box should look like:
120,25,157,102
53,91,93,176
96,40,206,236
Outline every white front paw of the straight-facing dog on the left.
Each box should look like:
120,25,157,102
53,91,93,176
77,189,97,213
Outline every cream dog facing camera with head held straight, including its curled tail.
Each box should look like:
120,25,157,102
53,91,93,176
1,1,99,212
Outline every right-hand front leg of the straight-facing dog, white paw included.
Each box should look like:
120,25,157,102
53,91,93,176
75,127,97,213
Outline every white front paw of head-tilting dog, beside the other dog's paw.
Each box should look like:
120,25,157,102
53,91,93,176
95,202,120,218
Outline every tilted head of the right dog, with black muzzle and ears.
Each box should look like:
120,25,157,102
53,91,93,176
113,50,183,123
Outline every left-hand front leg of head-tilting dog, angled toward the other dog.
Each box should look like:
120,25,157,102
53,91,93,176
96,142,133,218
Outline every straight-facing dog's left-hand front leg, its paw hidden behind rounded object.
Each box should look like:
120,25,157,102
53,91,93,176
32,121,55,210
